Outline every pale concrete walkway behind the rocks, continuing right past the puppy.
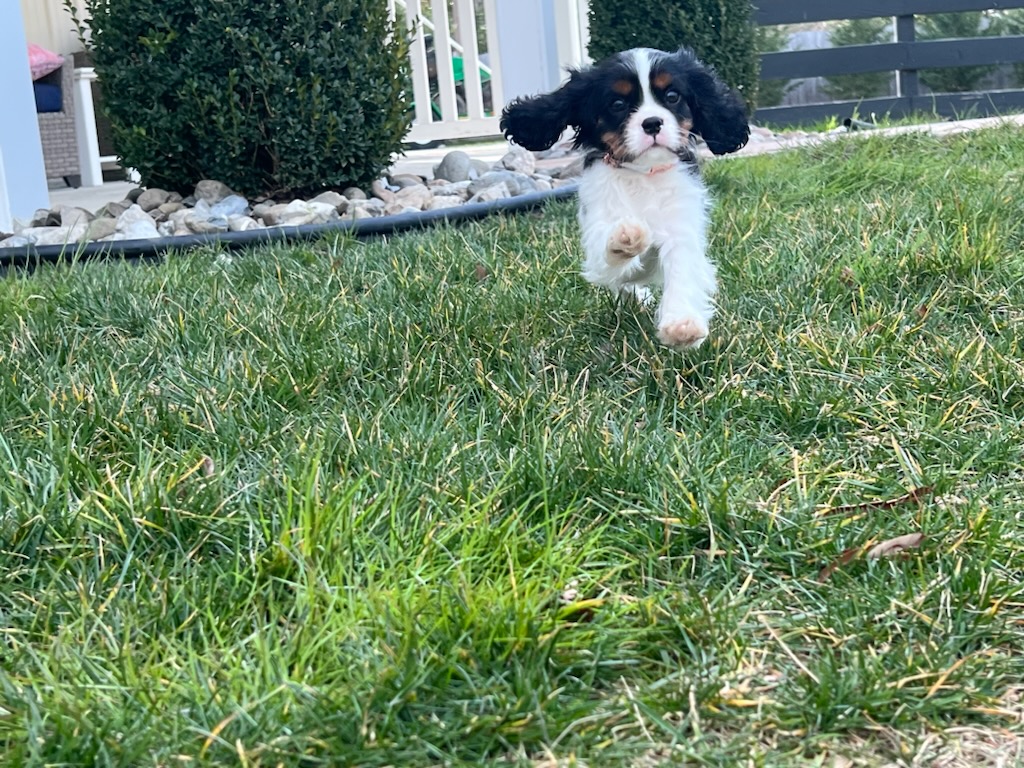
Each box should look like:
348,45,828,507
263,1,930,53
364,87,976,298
41,115,1024,211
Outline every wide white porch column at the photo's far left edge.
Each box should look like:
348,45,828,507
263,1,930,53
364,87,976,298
0,2,50,228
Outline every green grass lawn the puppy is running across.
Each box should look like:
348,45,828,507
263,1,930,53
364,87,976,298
6,128,1024,767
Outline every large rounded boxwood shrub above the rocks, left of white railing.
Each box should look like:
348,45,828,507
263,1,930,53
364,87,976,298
68,0,411,197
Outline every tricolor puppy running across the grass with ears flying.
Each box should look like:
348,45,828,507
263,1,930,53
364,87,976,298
501,48,750,347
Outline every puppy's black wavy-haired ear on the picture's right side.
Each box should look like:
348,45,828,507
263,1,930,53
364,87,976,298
677,48,751,155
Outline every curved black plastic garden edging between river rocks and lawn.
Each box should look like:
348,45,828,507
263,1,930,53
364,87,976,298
0,184,577,270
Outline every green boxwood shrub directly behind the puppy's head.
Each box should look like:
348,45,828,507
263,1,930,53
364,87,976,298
588,0,761,111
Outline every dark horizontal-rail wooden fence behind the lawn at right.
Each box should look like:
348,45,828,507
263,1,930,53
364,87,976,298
754,0,1024,124
